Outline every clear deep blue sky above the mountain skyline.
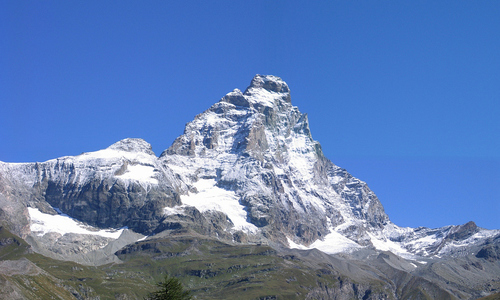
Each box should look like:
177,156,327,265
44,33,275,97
0,0,500,229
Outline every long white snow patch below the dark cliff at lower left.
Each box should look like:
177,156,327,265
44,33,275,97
28,207,125,239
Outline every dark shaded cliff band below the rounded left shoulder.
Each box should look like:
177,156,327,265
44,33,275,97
41,180,180,234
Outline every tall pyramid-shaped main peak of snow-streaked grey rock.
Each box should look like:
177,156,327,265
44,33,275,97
160,75,389,244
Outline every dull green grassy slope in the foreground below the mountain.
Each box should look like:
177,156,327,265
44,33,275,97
0,229,394,300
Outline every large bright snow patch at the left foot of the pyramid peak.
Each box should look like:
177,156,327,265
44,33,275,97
181,179,257,233
